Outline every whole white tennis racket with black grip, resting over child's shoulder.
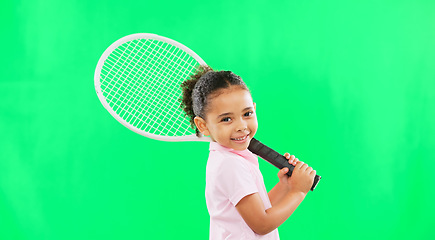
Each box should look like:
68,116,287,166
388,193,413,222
94,33,320,190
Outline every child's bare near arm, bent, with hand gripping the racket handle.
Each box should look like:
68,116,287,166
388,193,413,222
236,162,316,235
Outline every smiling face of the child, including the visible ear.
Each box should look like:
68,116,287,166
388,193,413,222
195,87,258,150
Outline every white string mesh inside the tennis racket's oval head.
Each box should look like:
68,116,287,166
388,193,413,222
101,39,198,136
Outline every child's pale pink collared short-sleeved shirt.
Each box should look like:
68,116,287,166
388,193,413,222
205,142,279,240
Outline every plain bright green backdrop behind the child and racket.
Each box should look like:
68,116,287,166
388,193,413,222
0,0,435,240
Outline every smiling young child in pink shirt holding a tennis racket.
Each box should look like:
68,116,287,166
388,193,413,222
182,67,316,240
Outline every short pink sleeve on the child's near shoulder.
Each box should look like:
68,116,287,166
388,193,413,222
218,158,258,206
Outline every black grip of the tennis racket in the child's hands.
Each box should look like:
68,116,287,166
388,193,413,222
248,138,322,191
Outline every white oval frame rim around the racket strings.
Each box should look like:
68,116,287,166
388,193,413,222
94,33,212,142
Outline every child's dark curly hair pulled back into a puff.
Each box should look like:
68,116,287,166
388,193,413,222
180,66,249,136
